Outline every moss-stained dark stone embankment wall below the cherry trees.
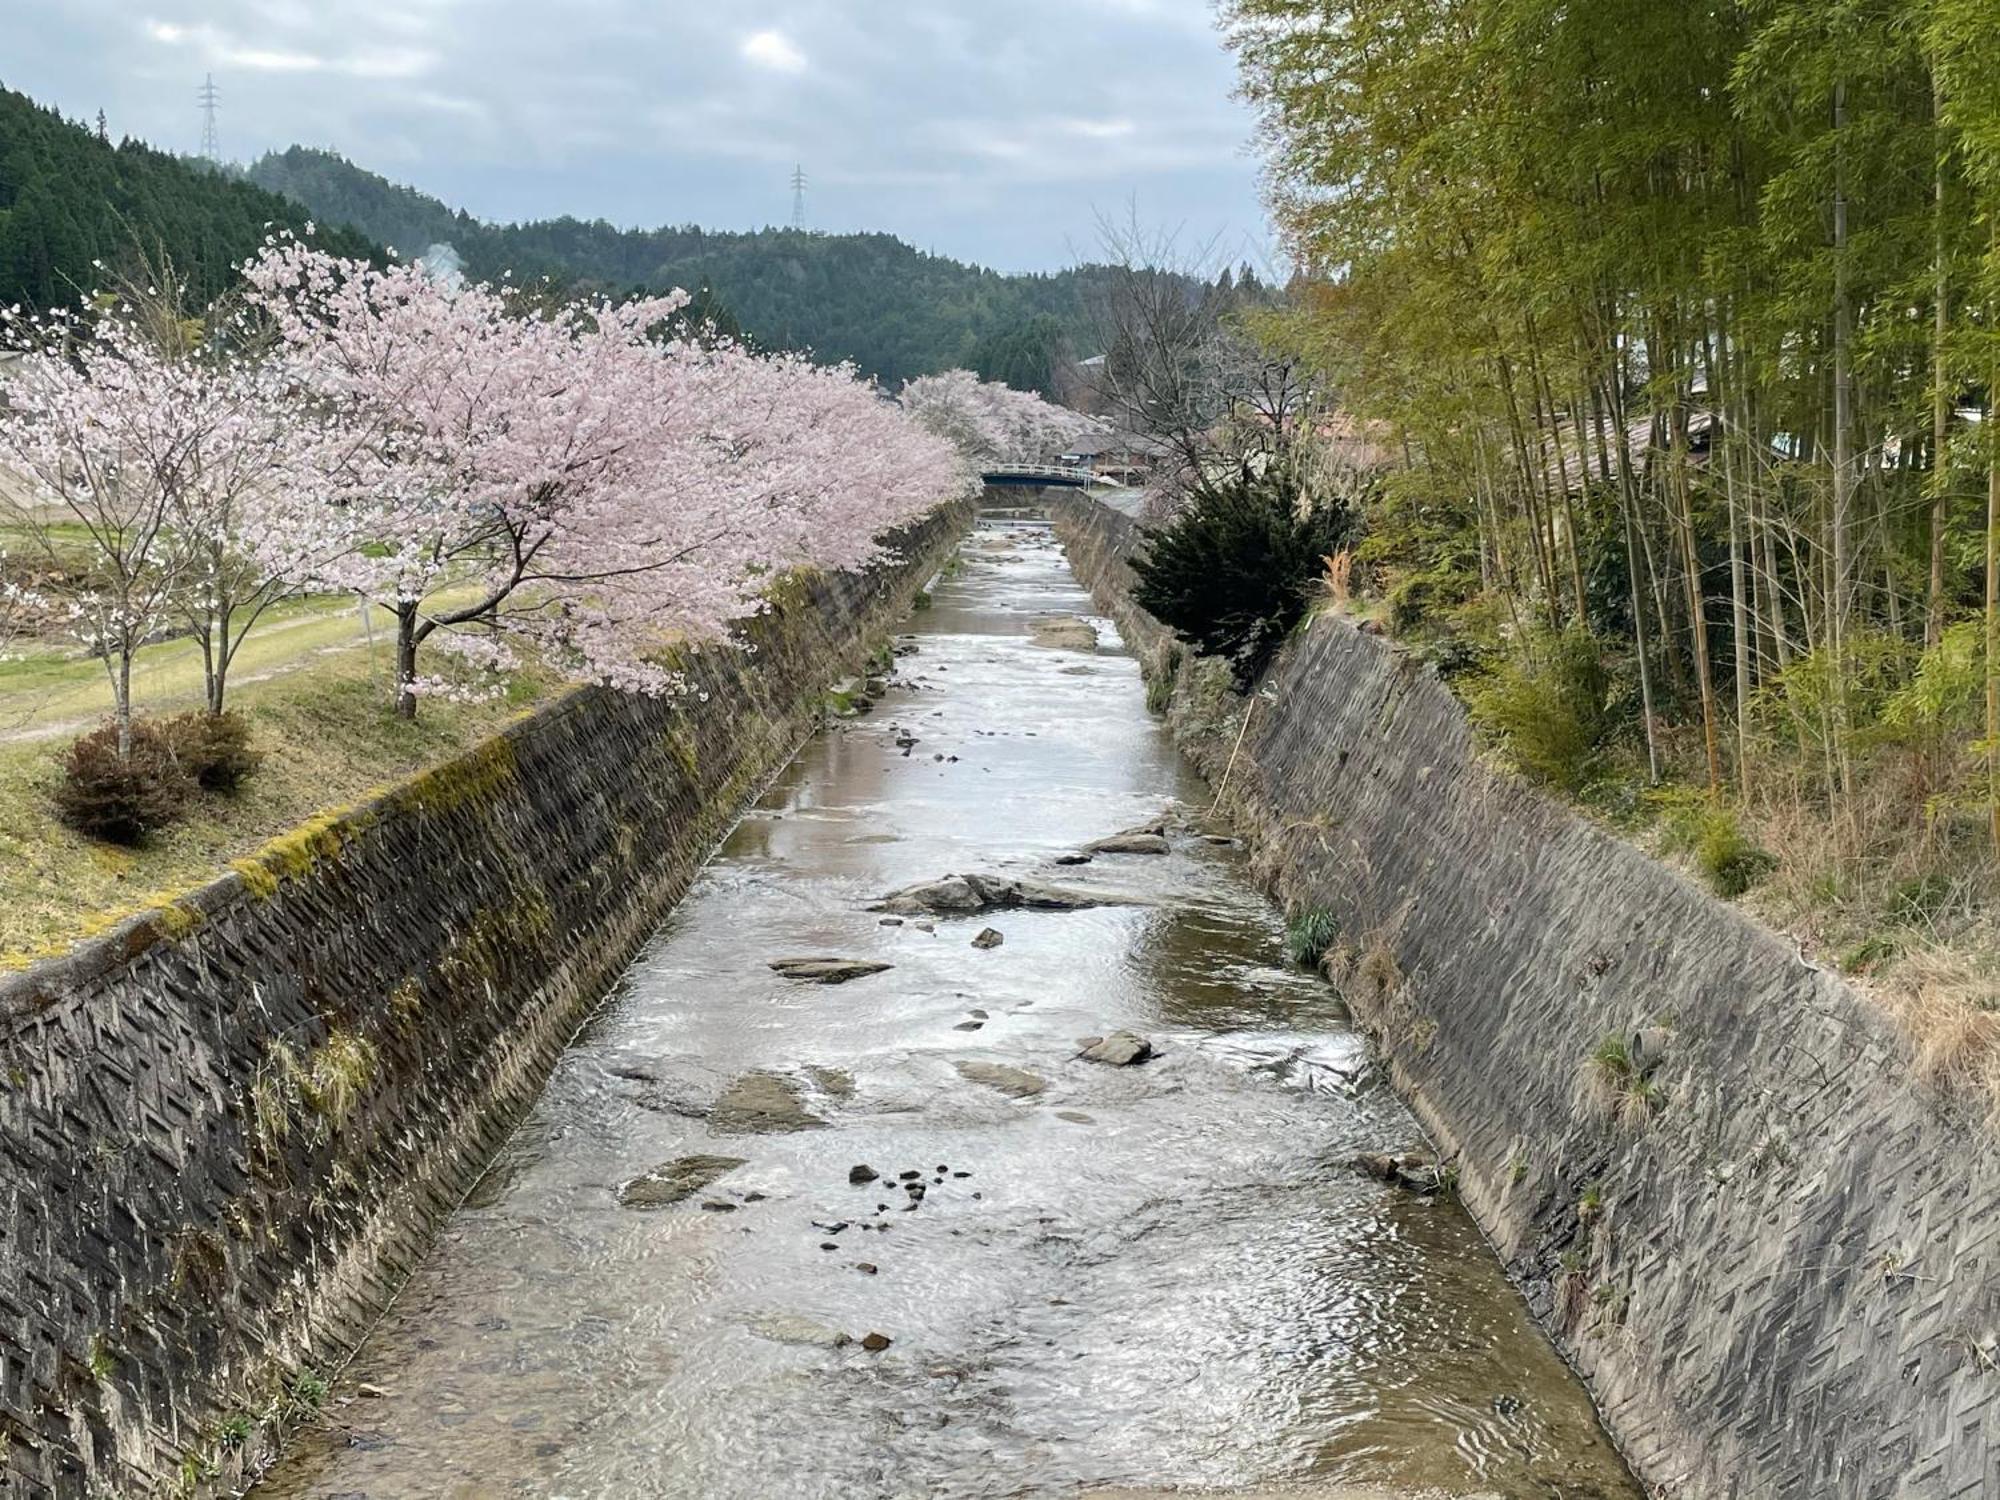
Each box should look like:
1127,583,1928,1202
0,504,970,1500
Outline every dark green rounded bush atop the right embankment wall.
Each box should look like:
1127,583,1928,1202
1132,468,1354,690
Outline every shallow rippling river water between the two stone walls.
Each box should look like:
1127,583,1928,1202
258,512,1638,1500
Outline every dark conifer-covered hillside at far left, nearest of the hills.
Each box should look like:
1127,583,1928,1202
0,88,370,308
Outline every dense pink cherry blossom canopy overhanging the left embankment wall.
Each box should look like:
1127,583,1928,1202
246,240,966,714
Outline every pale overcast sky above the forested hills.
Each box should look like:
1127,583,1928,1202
0,0,1268,270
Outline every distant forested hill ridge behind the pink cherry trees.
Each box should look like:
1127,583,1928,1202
250,146,1090,388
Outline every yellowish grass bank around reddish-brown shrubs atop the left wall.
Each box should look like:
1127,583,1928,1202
0,648,558,970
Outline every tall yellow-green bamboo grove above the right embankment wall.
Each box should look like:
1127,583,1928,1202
1222,0,2000,912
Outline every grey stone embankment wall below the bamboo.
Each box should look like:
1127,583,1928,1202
1052,498,2000,1500
